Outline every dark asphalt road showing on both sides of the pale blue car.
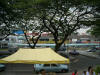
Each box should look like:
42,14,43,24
0,55,100,75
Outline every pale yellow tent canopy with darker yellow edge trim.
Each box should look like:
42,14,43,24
0,48,69,64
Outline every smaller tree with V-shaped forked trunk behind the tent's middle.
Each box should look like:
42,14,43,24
8,0,44,48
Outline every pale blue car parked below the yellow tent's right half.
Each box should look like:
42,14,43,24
34,64,69,72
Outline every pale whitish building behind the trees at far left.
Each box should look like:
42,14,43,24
0,35,26,48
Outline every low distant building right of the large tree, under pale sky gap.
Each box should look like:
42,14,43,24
69,34,100,43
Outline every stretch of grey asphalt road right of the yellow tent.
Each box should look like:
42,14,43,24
70,55,100,72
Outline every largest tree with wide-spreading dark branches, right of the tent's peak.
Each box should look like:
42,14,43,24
34,0,95,51
